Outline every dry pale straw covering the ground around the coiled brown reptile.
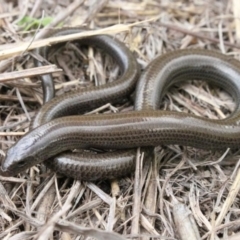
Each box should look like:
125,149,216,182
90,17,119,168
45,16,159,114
0,0,240,240
